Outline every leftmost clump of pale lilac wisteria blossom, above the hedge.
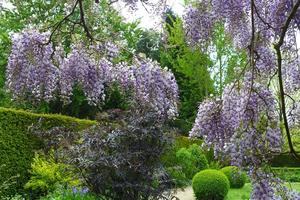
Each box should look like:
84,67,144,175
6,31,59,101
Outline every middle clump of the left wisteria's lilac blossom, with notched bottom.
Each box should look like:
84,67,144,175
60,47,108,105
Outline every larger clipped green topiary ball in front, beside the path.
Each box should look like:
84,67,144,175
192,169,230,200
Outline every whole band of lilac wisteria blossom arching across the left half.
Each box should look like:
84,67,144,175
6,30,178,119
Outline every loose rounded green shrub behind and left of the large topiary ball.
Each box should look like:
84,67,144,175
176,144,208,180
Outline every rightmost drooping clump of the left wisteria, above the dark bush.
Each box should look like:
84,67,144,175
131,59,178,118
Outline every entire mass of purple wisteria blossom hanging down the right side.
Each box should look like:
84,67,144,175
184,0,300,200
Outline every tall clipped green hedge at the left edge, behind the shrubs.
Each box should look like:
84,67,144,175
0,107,96,195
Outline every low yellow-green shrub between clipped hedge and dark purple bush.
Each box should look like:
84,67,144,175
24,154,80,193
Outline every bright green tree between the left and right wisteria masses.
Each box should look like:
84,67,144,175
160,14,214,131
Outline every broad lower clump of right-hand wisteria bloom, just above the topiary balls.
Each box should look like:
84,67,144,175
190,73,282,167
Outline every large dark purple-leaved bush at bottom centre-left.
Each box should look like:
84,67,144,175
43,111,169,200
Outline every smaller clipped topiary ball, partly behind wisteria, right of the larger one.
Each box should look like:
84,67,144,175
221,166,247,188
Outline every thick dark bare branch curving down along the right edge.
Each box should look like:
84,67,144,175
274,0,300,160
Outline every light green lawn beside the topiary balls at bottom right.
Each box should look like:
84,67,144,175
226,183,300,200
